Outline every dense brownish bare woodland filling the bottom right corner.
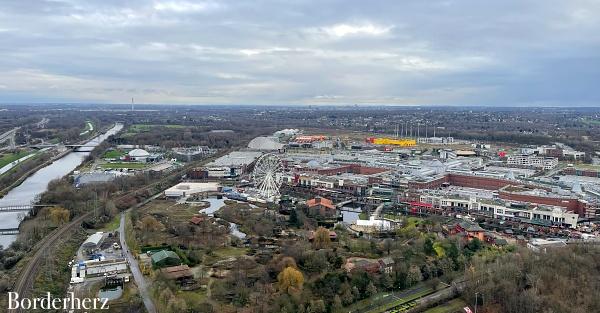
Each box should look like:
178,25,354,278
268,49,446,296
464,245,600,313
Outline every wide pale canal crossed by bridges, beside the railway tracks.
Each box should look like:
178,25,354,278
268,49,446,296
0,123,123,247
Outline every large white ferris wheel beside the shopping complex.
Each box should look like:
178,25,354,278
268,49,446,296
252,153,283,199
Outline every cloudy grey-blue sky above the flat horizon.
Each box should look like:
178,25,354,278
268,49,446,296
0,0,600,106
